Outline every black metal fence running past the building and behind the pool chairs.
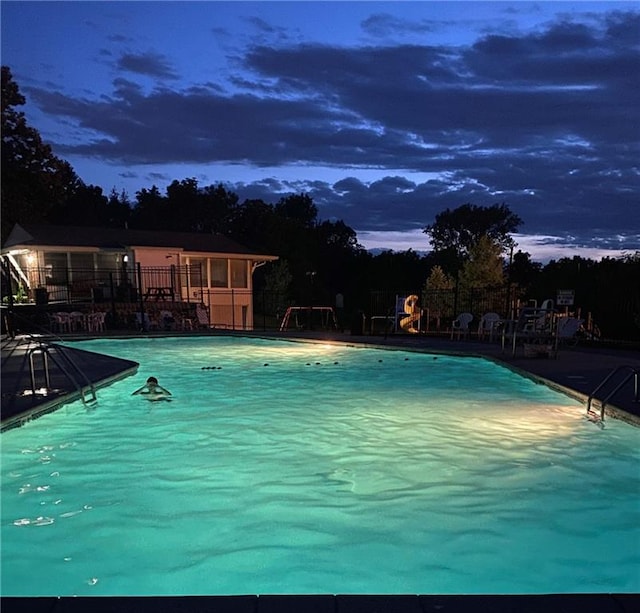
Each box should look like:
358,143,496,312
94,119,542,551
2,258,640,341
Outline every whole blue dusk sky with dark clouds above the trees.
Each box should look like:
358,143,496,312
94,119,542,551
0,1,640,261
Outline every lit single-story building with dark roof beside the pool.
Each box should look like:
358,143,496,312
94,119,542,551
2,224,278,330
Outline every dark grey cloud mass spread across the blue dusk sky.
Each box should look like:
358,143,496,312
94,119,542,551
20,11,640,246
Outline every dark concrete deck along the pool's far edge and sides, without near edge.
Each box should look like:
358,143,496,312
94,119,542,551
1,331,640,429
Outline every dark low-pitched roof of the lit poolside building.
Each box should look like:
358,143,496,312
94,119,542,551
3,224,277,260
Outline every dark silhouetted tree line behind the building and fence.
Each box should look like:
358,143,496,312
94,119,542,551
1,66,640,339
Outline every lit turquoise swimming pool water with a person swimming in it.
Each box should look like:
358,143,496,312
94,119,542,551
1,337,640,596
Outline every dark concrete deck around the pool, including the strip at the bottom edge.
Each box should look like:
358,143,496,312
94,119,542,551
0,331,640,613
